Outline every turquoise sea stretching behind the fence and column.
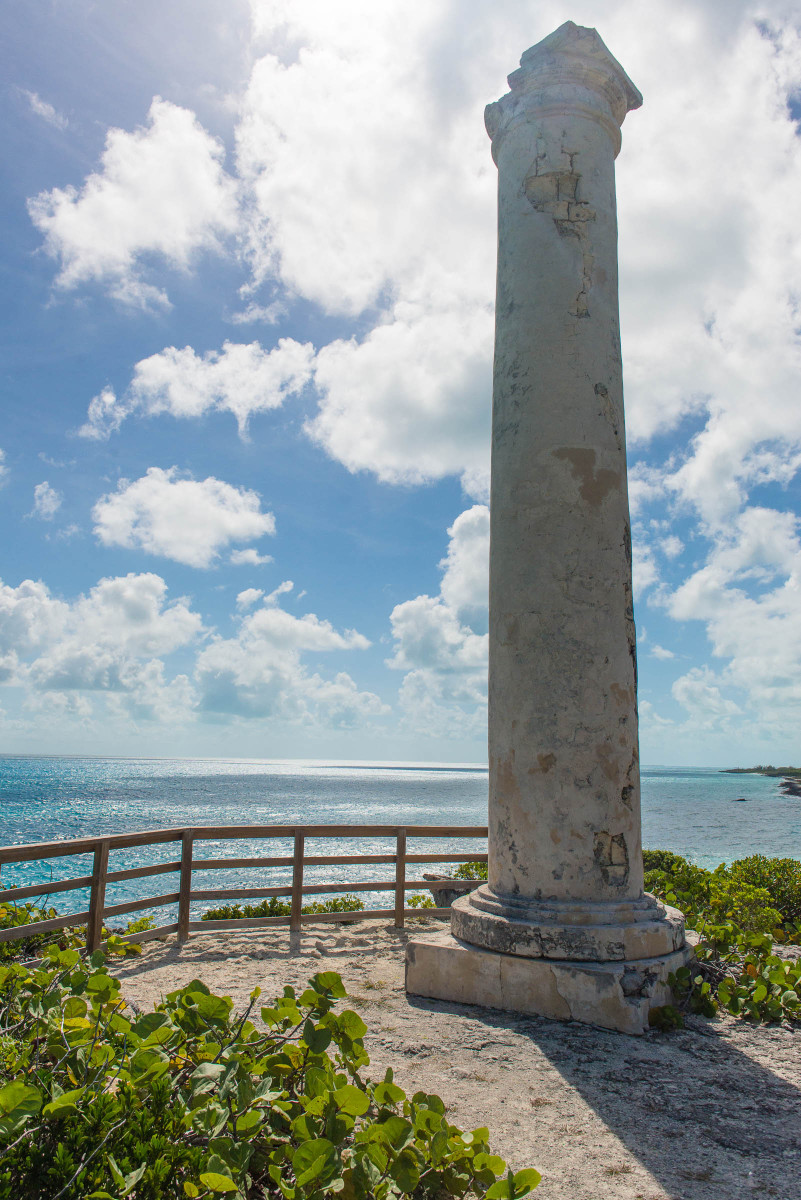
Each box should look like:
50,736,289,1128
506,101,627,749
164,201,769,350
0,755,801,919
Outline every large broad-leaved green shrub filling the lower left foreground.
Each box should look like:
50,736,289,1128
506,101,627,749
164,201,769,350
0,947,540,1200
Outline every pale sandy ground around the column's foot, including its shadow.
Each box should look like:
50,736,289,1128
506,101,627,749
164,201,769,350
107,922,801,1200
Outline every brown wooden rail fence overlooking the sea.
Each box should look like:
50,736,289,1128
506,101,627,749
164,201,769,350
0,826,487,950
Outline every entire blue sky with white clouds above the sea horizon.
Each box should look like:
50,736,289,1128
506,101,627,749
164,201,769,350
0,0,801,766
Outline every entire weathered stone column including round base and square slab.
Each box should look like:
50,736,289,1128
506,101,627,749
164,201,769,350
408,22,689,1032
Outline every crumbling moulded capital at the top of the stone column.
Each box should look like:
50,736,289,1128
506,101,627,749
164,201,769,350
484,20,643,162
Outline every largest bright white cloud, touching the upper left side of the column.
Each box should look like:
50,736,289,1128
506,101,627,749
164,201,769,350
237,0,495,494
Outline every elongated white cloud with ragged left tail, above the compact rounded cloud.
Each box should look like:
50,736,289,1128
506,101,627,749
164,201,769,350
78,337,314,439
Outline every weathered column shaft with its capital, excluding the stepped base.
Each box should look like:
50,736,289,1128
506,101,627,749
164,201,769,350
487,22,643,902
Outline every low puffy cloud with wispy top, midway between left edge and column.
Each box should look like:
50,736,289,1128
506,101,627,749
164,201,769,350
194,583,389,728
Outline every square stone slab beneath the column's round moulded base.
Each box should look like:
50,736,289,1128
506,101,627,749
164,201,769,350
406,931,693,1033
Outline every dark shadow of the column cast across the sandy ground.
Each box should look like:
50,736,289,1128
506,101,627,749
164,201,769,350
409,996,801,1200
